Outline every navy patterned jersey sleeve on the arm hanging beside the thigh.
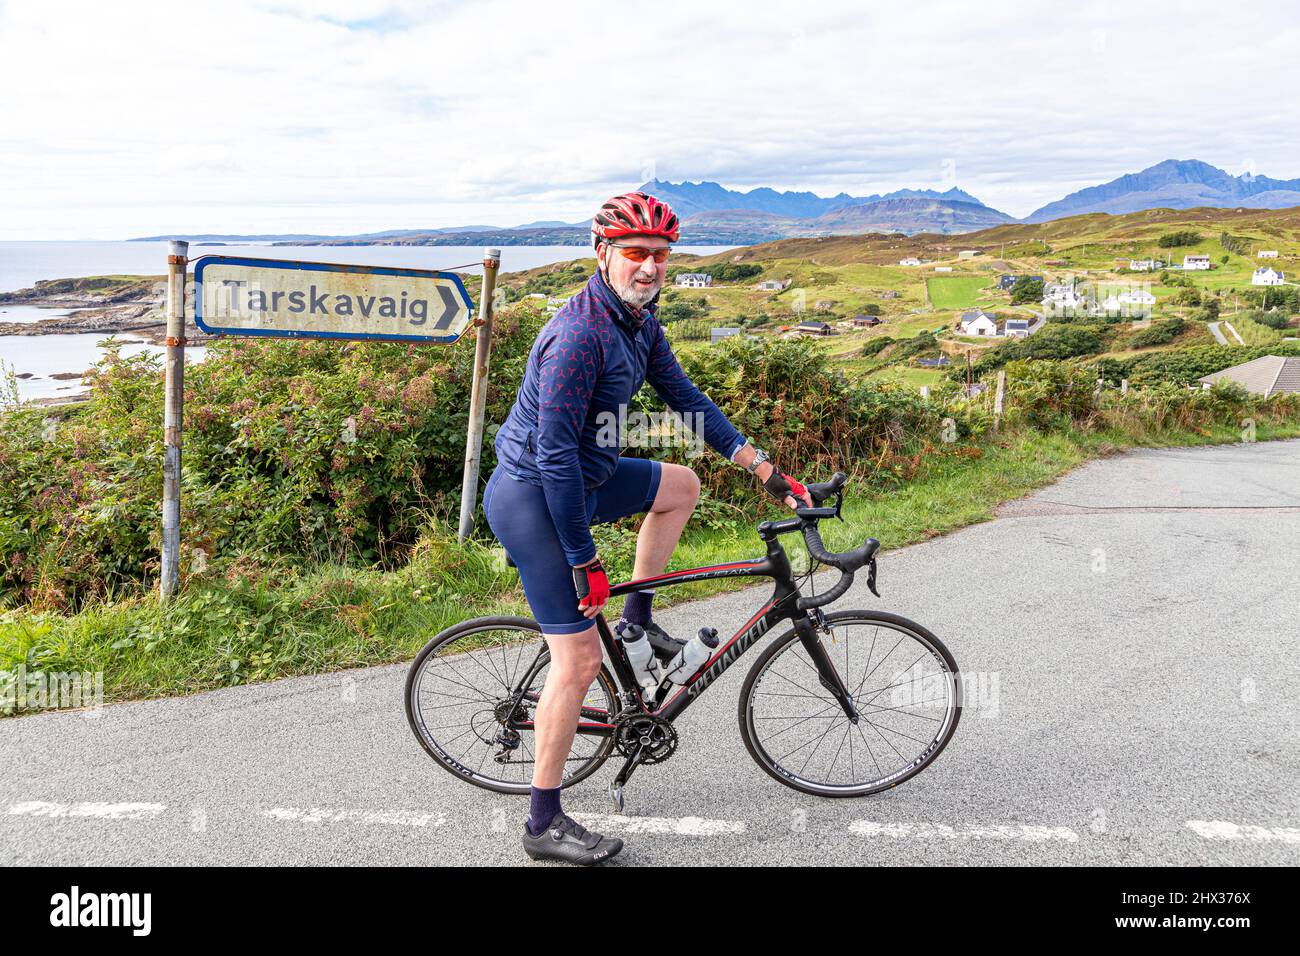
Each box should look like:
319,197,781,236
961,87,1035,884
537,324,605,567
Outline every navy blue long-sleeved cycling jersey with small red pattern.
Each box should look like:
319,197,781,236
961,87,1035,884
495,272,745,566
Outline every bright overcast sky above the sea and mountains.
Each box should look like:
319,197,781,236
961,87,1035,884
0,0,1300,239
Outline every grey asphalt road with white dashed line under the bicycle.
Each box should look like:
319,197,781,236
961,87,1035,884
0,442,1300,866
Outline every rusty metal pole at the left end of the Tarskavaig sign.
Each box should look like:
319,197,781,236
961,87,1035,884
159,239,190,601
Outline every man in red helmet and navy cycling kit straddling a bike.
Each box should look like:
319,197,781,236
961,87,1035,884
484,193,811,865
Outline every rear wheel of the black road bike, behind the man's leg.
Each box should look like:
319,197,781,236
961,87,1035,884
406,618,619,793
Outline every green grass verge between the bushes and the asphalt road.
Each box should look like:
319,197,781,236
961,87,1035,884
0,424,1300,701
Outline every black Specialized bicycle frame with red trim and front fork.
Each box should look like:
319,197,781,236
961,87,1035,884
510,522,857,736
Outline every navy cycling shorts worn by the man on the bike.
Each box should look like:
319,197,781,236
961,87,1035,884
484,458,663,633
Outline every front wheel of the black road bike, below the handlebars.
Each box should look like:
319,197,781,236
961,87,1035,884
740,611,962,797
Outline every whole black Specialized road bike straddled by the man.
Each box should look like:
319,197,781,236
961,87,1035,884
406,472,962,810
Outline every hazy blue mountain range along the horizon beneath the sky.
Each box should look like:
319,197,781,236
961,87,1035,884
131,160,1300,246
